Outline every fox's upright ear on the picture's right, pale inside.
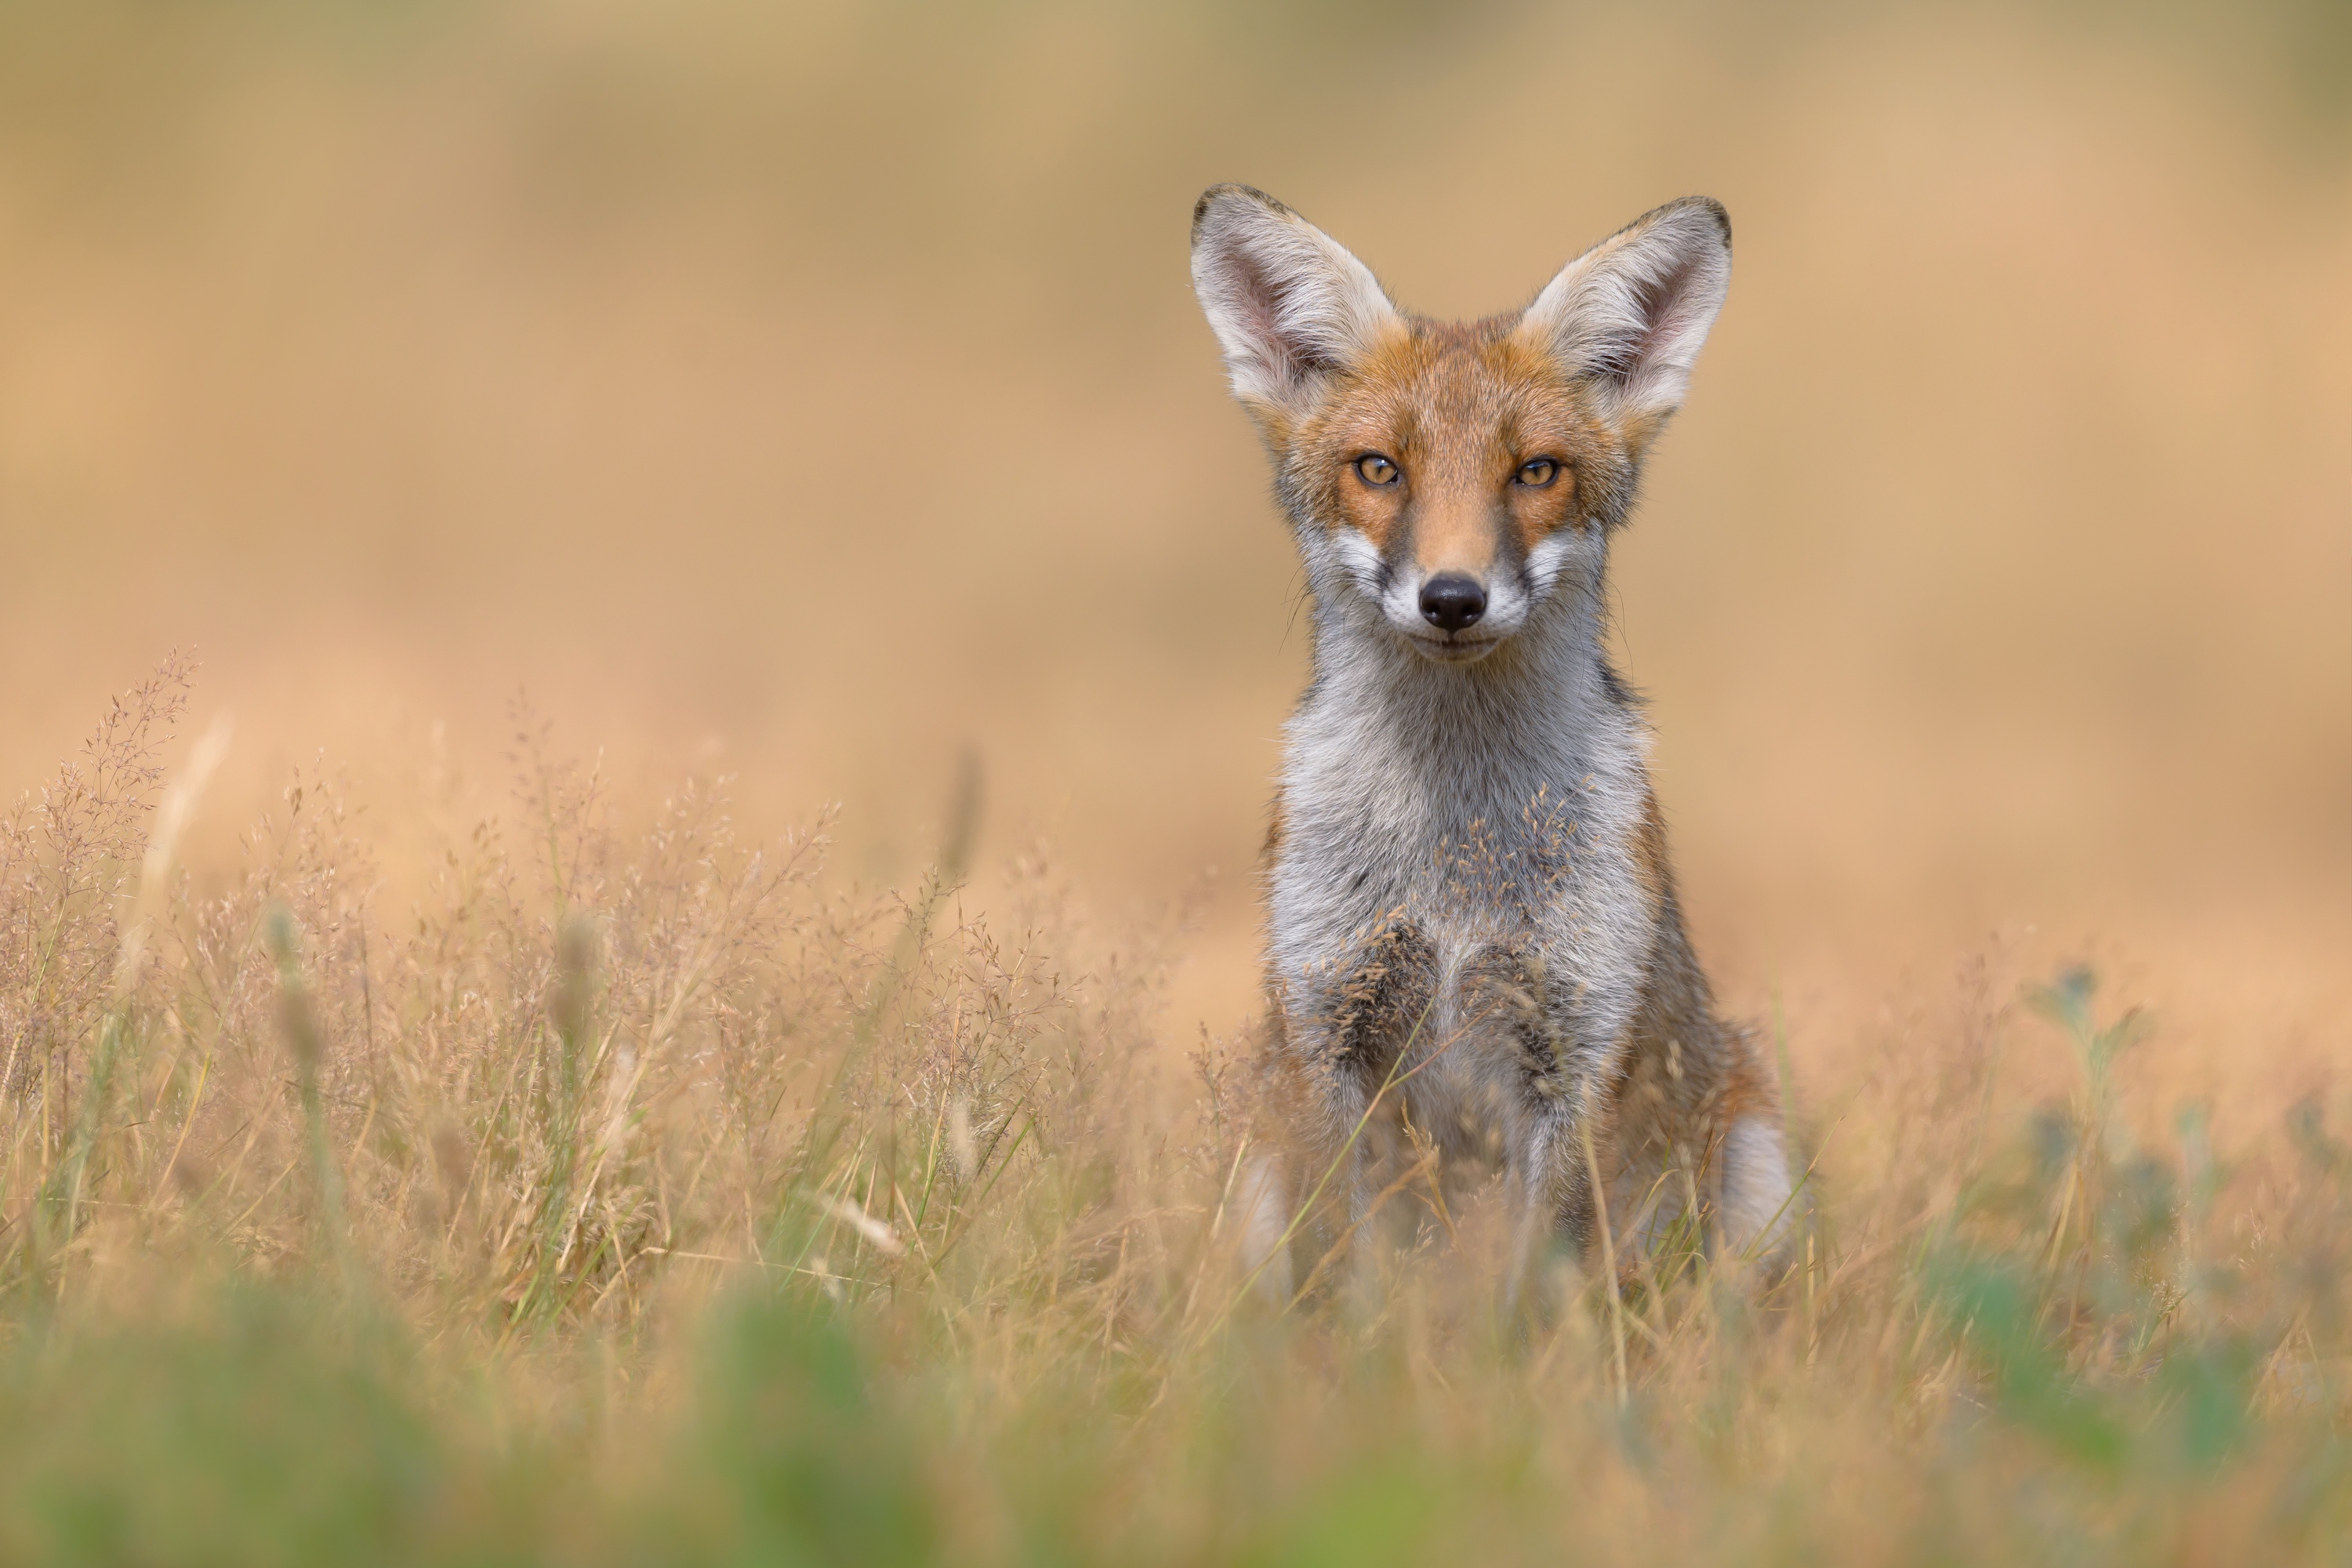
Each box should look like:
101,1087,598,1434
1517,195,1731,442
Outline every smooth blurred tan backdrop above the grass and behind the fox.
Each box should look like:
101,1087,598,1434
0,0,2352,1091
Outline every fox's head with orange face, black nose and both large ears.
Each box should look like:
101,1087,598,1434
1192,186,1731,663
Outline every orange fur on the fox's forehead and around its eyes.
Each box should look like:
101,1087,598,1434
1282,315,1621,548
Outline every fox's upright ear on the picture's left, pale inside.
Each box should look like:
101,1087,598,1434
1192,186,1399,419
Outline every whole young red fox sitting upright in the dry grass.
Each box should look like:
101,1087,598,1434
1192,183,1792,1300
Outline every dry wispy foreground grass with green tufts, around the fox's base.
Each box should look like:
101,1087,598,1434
0,663,2352,1566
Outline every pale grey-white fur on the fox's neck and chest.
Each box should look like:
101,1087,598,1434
1270,620,1656,1072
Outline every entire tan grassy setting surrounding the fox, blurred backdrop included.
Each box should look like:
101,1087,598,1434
0,0,2352,1566
